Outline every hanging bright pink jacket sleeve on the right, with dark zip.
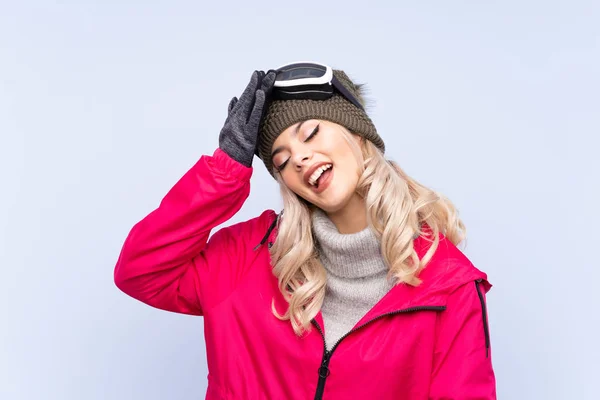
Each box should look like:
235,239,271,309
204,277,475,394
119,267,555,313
429,280,496,400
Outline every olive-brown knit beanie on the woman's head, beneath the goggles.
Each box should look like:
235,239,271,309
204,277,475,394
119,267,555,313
258,70,385,177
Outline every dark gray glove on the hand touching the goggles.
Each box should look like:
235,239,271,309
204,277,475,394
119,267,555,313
219,71,275,167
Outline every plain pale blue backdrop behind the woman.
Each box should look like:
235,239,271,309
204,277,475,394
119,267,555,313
0,0,600,400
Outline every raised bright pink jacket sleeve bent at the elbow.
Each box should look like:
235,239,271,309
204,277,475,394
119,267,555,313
114,150,252,315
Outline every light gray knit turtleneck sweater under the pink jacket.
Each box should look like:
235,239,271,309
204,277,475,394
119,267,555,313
312,210,393,350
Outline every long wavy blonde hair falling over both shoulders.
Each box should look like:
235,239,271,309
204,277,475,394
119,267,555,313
270,126,466,336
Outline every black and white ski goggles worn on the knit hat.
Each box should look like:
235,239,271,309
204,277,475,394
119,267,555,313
272,62,364,111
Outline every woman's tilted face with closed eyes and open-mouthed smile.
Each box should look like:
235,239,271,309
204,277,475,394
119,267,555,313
272,119,362,213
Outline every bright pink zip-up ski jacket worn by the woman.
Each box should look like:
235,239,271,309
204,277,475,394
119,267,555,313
114,150,496,400
